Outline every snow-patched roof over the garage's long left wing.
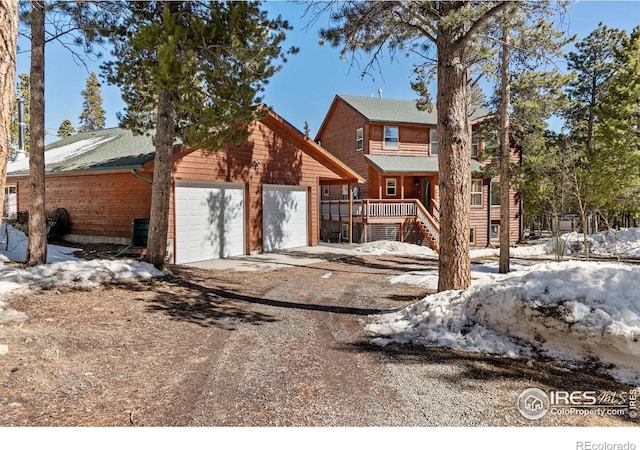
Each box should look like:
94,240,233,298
7,128,155,176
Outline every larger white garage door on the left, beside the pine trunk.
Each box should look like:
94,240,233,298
175,182,245,264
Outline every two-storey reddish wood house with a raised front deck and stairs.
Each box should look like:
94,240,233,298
316,95,520,250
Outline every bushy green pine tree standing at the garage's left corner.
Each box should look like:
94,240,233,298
104,1,294,268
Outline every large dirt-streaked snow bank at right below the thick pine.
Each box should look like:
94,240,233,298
367,262,640,384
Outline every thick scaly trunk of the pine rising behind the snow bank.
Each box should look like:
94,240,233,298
436,7,471,291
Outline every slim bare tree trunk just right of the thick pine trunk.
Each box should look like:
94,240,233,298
498,25,511,273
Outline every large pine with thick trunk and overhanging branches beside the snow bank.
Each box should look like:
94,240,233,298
316,1,576,291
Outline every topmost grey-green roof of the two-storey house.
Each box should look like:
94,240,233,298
338,95,489,126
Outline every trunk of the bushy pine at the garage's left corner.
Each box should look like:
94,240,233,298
146,90,175,270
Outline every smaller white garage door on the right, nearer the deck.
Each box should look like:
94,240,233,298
262,186,309,252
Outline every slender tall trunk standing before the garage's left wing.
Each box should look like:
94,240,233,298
26,1,47,266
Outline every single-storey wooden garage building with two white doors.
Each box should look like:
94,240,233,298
7,112,363,264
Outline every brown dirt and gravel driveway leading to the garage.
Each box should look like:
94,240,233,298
0,251,637,427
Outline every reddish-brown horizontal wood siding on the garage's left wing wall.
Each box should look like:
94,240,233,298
13,172,151,241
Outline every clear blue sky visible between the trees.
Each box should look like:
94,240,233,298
17,1,640,143
